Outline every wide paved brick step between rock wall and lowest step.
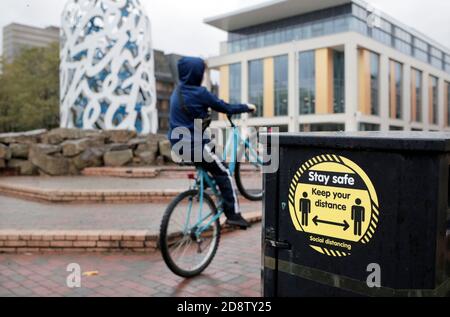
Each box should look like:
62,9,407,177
0,172,260,204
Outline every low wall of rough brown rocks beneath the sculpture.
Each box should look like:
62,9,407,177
0,129,171,176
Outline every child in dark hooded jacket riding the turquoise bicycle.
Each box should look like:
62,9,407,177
169,57,256,229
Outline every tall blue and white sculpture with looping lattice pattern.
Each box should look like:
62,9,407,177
60,0,158,135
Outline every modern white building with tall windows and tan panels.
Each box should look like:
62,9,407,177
205,0,450,132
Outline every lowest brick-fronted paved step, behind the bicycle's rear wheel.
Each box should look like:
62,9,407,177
0,211,262,254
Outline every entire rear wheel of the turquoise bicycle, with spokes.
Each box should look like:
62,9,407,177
159,190,220,278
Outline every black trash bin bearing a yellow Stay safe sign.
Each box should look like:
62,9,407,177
263,132,450,297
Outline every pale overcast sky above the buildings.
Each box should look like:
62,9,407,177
0,0,450,57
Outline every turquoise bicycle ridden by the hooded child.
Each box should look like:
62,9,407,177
159,117,263,278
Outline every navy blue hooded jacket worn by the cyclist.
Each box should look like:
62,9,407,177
168,57,249,146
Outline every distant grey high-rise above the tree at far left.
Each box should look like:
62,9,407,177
3,23,59,63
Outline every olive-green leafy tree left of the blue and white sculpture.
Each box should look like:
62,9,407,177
0,43,59,132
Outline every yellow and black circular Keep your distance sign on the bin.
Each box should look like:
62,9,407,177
289,154,379,257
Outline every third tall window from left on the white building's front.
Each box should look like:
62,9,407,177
274,55,289,116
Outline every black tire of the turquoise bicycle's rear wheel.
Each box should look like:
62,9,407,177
159,190,221,278
